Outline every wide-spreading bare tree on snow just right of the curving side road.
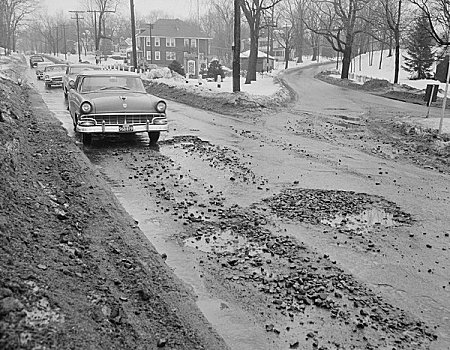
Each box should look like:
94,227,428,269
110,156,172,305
305,0,369,79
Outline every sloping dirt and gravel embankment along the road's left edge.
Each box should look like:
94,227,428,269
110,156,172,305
0,56,227,350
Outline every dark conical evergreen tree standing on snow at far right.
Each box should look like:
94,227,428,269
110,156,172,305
403,16,434,79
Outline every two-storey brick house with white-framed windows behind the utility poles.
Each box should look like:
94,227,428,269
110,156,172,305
136,19,211,76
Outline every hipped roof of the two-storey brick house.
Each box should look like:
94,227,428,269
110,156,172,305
137,19,211,39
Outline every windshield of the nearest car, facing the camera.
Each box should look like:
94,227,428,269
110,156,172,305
81,76,145,92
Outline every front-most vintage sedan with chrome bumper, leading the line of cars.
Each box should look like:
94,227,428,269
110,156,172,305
68,70,168,145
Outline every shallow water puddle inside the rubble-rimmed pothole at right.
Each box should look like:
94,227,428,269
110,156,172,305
321,208,396,231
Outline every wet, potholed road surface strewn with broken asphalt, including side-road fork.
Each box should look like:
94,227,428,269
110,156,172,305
29,63,450,350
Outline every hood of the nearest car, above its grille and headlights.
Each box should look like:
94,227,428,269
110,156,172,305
87,91,161,113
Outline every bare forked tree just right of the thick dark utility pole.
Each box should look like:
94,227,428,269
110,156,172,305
241,0,282,84
